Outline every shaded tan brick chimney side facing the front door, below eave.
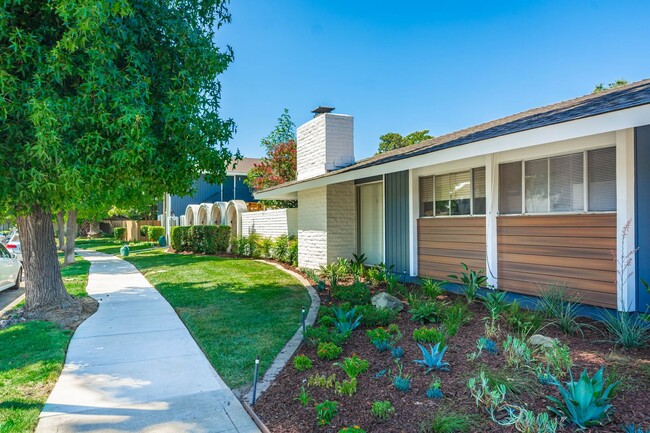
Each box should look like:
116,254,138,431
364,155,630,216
327,182,357,262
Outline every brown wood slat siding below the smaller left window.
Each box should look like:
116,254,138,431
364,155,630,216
418,217,485,280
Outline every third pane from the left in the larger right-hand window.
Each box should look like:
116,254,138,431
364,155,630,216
549,153,585,212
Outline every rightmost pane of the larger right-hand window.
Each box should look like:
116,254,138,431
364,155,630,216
587,147,616,211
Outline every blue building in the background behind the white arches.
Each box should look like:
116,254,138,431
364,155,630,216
158,158,260,216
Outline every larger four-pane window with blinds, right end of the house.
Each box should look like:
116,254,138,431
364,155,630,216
499,147,616,214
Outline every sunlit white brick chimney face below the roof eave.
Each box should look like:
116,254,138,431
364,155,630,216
298,187,327,269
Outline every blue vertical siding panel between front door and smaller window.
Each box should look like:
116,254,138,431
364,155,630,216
384,171,411,275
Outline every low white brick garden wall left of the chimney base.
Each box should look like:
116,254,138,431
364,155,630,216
241,209,298,238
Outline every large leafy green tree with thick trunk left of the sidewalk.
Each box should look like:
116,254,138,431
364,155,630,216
0,0,234,317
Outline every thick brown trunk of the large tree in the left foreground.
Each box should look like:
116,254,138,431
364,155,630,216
17,207,74,314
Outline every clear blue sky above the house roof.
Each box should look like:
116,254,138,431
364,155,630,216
217,0,650,159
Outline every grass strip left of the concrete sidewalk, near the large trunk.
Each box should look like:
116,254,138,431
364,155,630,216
0,257,90,433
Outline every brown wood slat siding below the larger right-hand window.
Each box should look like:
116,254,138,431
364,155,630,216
497,214,616,308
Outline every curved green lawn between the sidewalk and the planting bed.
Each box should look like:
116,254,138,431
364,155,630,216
127,250,310,388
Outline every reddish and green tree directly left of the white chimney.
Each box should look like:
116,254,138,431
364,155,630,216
246,108,298,208
